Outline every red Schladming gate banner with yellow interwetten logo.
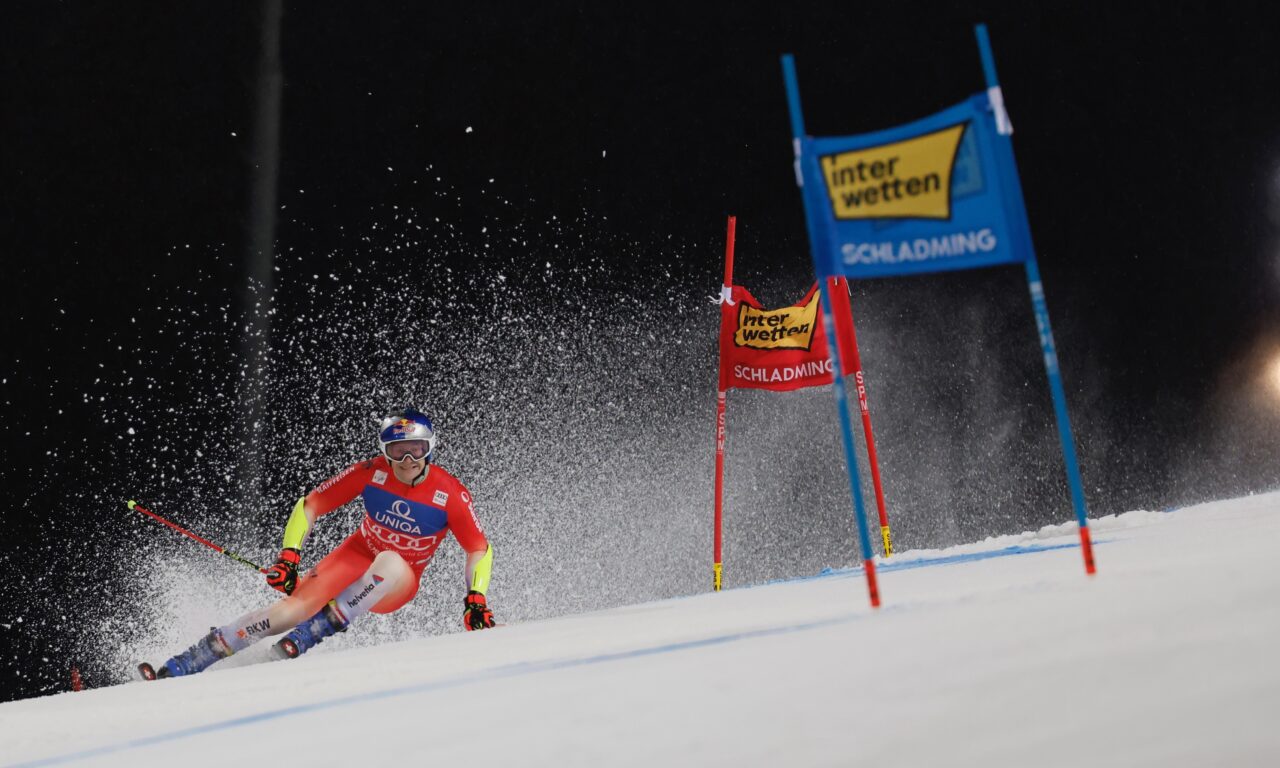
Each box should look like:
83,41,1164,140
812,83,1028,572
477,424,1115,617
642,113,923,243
719,278,856,392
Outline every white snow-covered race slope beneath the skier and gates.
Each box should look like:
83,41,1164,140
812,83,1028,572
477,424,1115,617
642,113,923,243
0,494,1280,768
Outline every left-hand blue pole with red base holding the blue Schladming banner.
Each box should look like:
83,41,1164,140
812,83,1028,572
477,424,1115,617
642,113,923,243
782,54,879,608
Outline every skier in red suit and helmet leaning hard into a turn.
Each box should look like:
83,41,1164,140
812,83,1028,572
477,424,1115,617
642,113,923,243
138,408,494,680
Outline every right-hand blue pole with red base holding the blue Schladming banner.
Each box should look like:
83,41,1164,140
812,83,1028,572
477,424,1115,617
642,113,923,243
974,24,1096,575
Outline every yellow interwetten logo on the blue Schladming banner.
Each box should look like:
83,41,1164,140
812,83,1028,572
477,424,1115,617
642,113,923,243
818,123,966,219
